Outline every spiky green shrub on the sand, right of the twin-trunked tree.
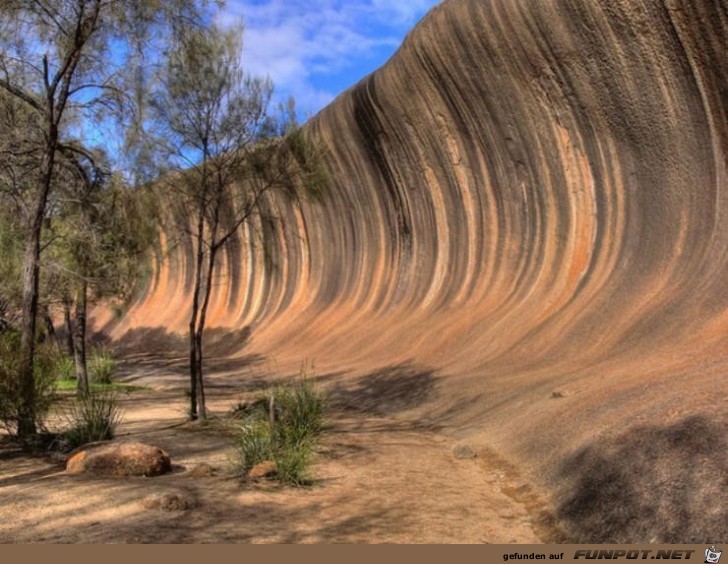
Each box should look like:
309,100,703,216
233,379,324,486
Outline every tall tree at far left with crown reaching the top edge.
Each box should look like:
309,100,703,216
0,0,210,438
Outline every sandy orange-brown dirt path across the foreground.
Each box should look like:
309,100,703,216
0,391,547,543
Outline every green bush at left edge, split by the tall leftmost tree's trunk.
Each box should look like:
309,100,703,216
0,330,60,436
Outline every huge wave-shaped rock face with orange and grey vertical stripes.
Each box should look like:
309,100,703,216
108,0,728,541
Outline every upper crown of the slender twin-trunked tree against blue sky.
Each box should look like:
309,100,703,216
152,24,273,167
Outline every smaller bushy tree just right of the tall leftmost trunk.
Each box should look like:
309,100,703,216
42,171,156,398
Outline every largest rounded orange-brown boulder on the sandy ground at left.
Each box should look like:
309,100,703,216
66,443,172,477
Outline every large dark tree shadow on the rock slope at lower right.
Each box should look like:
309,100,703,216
558,416,728,543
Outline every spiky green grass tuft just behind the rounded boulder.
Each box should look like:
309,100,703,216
61,392,121,450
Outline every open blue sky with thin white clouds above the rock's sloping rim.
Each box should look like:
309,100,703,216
221,0,439,115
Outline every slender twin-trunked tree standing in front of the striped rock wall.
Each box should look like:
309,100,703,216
154,26,326,420
